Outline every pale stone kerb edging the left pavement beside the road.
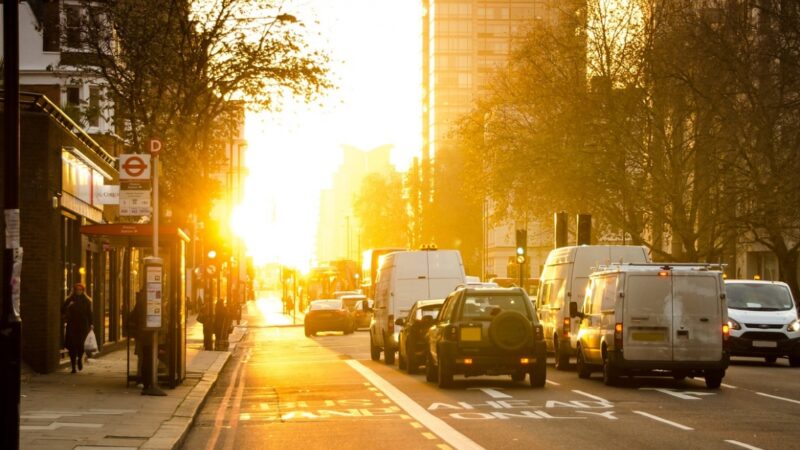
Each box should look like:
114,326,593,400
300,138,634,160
139,329,247,450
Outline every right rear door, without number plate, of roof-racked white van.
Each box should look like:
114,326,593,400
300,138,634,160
671,272,723,361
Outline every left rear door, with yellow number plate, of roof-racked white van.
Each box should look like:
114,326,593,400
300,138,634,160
622,274,672,361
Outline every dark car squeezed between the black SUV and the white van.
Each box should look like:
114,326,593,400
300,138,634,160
396,298,444,374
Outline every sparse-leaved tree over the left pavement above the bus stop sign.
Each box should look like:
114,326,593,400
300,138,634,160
70,0,330,225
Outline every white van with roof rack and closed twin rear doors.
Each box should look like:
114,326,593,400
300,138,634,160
570,264,730,389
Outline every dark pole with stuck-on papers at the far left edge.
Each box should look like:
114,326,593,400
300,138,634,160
0,0,22,449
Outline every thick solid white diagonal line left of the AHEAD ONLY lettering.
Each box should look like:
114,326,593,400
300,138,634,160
345,359,483,450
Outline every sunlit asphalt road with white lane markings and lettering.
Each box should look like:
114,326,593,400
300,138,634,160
184,299,800,449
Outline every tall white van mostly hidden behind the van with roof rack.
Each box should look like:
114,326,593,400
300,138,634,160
536,245,650,370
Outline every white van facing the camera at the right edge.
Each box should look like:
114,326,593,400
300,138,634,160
725,280,800,367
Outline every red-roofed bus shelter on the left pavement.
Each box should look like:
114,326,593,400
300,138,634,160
81,223,189,388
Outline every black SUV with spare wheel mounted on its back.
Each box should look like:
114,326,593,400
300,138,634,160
425,287,547,388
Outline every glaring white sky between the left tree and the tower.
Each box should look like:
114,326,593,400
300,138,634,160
232,0,422,269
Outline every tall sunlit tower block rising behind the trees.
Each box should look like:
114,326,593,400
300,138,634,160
422,0,562,277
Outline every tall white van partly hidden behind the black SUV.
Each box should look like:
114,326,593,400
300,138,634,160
369,250,466,364
